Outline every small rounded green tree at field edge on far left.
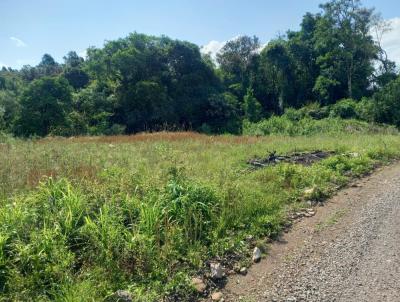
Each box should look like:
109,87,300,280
17,77,72,136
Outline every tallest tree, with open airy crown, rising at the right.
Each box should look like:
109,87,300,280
314,0,378,102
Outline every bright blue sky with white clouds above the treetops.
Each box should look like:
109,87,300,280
0,0,400,68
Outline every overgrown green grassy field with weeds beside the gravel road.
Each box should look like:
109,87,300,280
0,133,400,301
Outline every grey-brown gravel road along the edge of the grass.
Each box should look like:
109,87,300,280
224,163,400,302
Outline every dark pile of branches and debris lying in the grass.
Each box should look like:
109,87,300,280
247,150,335,168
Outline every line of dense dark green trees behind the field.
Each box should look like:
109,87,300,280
0,0,400,136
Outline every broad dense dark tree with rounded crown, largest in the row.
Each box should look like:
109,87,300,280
85,33,220,133
